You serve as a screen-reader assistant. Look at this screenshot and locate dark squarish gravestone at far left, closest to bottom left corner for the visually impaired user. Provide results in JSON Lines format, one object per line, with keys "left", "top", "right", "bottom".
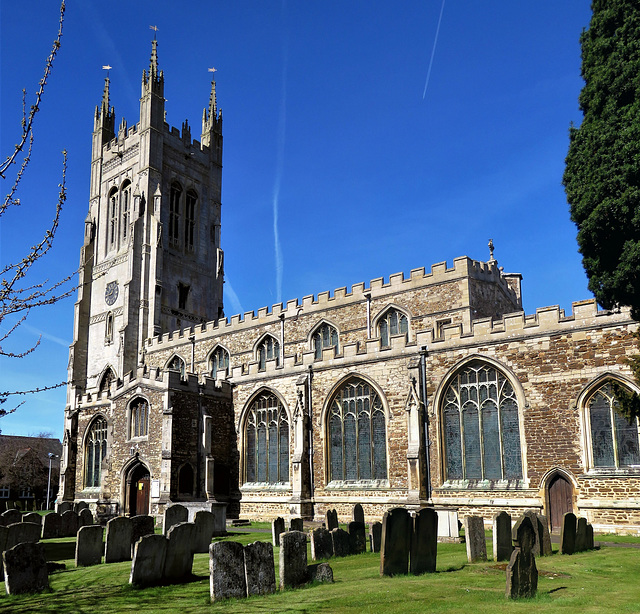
{"left": 2, "top": 543, "right": 49, "bottom": 595}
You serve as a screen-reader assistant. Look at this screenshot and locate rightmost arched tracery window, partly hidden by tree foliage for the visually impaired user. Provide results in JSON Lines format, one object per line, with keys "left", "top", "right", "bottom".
{"left": 587, "top": 383, "right": 640, "bottom": 468}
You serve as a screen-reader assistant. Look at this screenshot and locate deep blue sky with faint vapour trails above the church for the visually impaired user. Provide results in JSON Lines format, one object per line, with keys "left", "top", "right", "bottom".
{"left": 0, "top": 0, "right": 591, "bottom": 436}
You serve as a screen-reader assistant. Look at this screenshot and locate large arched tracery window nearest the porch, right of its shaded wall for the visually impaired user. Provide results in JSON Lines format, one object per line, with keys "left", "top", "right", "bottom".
{"left": 244, "top": 392, "right": 289, "bottom": 484}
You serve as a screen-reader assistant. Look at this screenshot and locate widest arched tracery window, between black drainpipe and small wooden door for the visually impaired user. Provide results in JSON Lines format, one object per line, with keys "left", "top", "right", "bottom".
{"left": 442, "top": 360, "right": 522, "bottom": 480}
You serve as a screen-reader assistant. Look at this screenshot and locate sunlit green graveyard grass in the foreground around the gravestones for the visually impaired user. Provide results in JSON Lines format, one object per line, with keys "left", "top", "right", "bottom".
{"left": 0, "top": 533, "right": 640, "bottom": 614}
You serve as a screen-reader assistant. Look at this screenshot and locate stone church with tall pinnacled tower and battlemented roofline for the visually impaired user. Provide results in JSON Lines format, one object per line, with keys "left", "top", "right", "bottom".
{"left": 58, "top": 41, "right": 640, "bottom": 532}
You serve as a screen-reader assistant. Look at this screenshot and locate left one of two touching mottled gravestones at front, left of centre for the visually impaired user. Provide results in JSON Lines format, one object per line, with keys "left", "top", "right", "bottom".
{"left": 209, "top": 542, "right": 248, "bottom": 601}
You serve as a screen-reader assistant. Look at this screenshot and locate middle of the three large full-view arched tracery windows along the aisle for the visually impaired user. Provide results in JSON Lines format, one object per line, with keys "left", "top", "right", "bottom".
{"left": 327, "top": 377, "right": 387, "bottom": 481}
